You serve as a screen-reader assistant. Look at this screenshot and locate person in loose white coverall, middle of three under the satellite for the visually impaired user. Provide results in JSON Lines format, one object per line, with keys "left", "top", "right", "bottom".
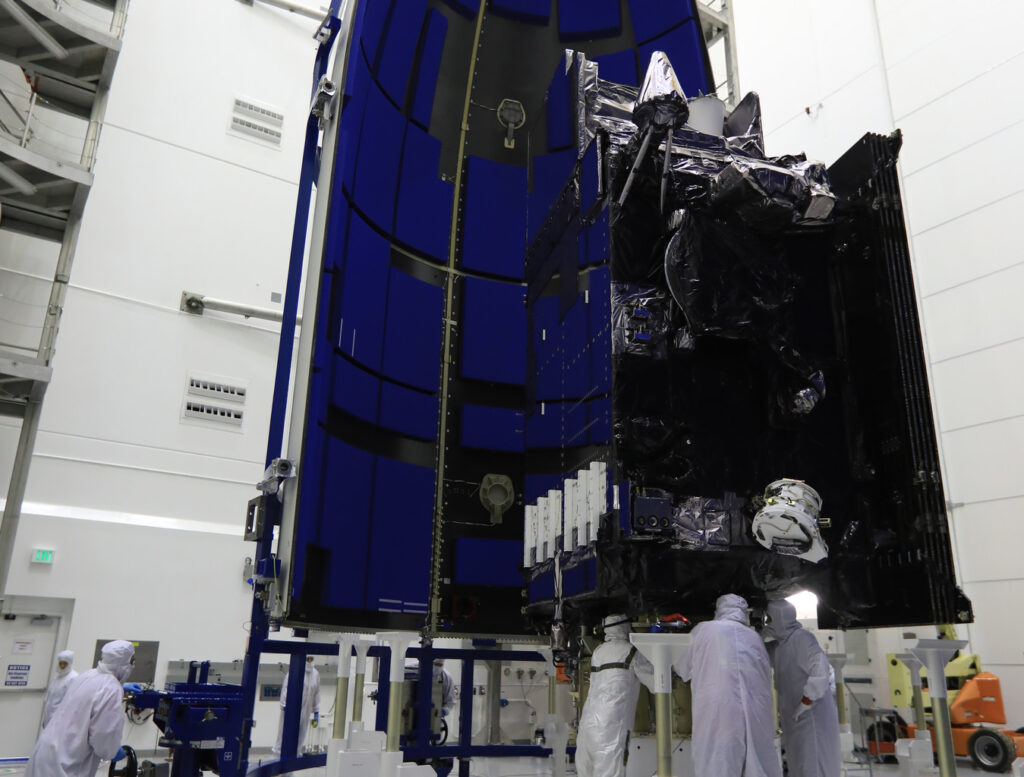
{"left": 673, "top": 594, "right": 782, "bottom": 777}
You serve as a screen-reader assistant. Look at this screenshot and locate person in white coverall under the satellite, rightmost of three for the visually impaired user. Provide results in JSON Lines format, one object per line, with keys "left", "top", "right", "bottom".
{"left": 764, "top": 601, "right": 842, "bottom": 777}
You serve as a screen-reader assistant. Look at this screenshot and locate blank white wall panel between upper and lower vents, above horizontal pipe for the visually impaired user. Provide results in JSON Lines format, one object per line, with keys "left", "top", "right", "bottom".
{"left": 74, "top": 127, "right": 298, "bottom": 309}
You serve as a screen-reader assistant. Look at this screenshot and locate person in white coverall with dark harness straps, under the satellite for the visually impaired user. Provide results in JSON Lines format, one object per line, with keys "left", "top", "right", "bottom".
{"left": 575, "top": 615, "right": 654, "bottom": 777}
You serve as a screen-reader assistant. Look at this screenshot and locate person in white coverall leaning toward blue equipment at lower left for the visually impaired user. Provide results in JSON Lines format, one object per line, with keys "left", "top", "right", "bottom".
{"left": 25, "top": 640, "right": 135, "bottom": 777}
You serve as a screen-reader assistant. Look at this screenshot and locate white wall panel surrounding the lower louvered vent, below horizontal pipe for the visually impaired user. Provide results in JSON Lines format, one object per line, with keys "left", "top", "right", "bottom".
{"left": 41, "top": 289, "right": 278, "bottom": 463}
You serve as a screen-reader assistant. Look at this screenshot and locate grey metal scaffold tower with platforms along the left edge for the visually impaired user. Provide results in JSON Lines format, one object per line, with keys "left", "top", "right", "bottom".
{"left": 0, "top": 0, "right": 128, "bottom": 595}
